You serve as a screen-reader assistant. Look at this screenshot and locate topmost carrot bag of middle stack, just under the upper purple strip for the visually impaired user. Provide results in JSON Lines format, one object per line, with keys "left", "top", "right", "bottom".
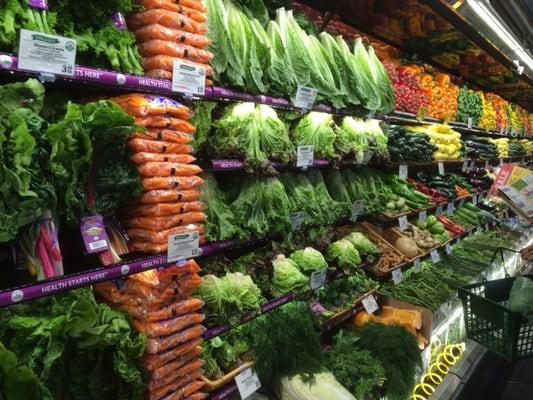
{"left": 112, "top": 93, "right": 193, "bottom": 119}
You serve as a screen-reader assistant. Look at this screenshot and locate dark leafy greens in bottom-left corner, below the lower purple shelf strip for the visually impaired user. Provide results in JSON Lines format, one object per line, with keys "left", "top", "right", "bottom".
{"left": 0, "top": 287, "right": 145, "bottom": 400}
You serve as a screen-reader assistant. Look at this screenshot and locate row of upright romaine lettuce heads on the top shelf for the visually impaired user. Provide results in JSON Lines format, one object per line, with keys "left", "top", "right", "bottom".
{"left": 205, "top": 0, "right": 394, "bottom": 114}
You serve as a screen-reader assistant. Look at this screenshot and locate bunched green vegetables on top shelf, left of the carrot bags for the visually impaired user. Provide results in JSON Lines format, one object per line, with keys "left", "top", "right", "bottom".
{"left": 0, "top": 0, "right": 143, "bottom": 74}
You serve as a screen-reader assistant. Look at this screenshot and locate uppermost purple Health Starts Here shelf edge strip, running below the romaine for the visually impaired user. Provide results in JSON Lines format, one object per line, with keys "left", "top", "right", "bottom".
{"left": 0, "top": 53, "right": 528, "bottom": 138}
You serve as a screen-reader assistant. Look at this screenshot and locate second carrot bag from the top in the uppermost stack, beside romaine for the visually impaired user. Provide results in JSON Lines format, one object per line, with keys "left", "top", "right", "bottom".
{"left": 128, "top": 9, "right": 207, "bottom": 35}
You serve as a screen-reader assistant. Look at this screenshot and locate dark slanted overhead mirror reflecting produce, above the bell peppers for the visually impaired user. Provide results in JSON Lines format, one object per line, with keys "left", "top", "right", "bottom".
{"left": 300, "top": 0, "right": 533, "bottom": 112}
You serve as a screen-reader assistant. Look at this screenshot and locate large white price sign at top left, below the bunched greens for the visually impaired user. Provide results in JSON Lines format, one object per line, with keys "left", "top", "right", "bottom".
{"left": 18, "top": 29, "right": 76, "bottom": 76}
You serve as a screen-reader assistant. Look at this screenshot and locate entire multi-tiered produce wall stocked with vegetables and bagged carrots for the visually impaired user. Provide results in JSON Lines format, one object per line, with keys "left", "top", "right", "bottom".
{"left": 0, "top": 0, "right": 533, "bottom": 400}
